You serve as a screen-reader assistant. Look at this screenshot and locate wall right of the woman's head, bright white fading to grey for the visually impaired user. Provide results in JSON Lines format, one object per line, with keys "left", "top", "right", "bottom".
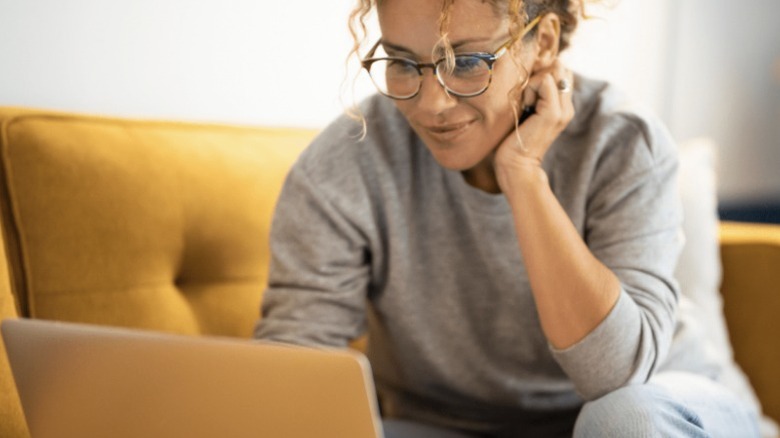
{"left": 569, "top": 0, "right": 780, "bottom": 204}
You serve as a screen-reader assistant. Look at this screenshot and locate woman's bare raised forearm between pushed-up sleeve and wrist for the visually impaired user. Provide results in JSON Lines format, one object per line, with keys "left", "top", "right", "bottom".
{"left": 502, "top": 164, "right": 620, "bottom": 349}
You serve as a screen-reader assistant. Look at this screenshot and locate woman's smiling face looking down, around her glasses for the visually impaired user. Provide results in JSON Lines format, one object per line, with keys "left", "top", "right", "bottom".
{"left": 378, "top": 0, "right": 529, "bottom": 175}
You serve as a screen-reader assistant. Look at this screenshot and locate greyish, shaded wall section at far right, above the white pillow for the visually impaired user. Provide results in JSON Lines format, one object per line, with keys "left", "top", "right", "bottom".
{"left": 669, "top": 0, "right": 780, "bottom": 203}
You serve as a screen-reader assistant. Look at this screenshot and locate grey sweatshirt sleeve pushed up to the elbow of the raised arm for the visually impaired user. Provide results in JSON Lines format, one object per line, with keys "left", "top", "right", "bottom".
{"left": 551, "top": 116, "right": 682, "bottom": 400}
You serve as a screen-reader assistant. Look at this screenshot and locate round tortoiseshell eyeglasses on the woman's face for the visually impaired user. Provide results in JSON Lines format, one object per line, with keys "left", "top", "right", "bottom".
{"left": 361, "top": 16, "right": 541, "bottom": 100}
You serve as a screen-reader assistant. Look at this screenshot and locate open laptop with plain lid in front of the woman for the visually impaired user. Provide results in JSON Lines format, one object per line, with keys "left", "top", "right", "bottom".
{"left": 0, "top": 319, "right": 382, "bottom": 438}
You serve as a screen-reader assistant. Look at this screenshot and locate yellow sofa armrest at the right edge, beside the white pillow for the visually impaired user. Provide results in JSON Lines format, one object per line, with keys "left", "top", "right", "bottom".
{"left": 720, "top": 222, "right": 780, "bottom": 421}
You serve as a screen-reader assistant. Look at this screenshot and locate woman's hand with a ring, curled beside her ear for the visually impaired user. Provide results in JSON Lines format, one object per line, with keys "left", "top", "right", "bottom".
{"left": 494, "top": 60, "right": 574, "bottom": 192}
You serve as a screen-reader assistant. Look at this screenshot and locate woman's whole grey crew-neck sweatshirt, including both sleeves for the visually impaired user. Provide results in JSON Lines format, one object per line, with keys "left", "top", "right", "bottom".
{"left": 256, "top": 77, "right": 711, "bottom": 432}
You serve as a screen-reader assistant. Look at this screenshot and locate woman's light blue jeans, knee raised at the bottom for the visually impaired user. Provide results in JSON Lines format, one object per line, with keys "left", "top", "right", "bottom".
{"left": 384, "top": 372, "right": 759, "bottom": 438}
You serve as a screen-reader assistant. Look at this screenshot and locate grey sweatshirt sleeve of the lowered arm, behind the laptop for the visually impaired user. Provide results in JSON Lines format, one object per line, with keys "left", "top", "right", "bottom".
{"left": 255, "top": 157, "right": 369, "bottom": 347}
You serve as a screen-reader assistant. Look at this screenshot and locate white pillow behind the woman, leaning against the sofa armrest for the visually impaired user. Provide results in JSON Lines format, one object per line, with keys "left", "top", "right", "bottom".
{"left": 675, "top": 138, "right": 777, "bottom": 437}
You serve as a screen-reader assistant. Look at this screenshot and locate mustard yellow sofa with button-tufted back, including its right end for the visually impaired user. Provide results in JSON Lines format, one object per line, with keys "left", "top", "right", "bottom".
{"left": 0, "top": 108, "right": 780, "bottom": 438}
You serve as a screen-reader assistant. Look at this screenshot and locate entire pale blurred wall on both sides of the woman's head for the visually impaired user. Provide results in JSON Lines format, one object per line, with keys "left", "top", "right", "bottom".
{"left": 0, "top": 0, "right": 780, "bottom": 199}
